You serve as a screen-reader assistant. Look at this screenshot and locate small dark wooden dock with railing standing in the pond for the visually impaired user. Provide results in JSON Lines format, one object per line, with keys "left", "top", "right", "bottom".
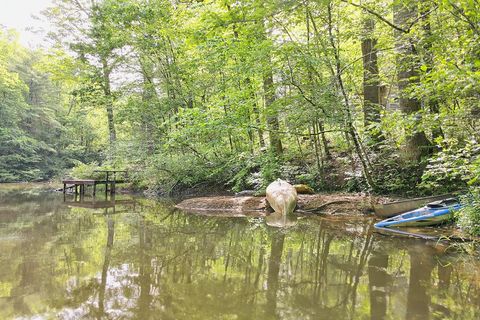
{"left": 62, "top": 170, "right": 127, "bottom": 196}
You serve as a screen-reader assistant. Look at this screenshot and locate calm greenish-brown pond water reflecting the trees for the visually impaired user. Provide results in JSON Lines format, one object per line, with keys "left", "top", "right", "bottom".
{"left": 0, "top": 185, "right": 480, "bottom": 319}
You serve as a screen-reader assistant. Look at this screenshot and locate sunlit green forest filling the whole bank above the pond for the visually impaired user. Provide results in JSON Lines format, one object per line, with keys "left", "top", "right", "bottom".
{"left": 0, "top": 0, "right": 480, "bottom": 195}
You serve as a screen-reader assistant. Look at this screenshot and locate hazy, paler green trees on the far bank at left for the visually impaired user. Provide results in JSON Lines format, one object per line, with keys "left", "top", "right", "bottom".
{"left": 0, "top": 30, "right": 99, "bottom": 182}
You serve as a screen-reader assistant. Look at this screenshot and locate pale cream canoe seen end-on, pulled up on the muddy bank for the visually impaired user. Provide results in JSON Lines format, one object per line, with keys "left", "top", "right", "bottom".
{"left": 266, "top": 179, "right": 298, "bottom": 214}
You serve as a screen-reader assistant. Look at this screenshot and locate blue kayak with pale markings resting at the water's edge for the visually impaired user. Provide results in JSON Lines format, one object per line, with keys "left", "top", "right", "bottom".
{"left": 375, "top": 198, "right": 462, "bottom": 228}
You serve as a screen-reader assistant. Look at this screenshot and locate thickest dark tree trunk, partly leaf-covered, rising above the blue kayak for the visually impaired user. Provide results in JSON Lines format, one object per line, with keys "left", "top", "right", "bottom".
{"left": 393, "top": 2, "right": 431, "bottom": 162}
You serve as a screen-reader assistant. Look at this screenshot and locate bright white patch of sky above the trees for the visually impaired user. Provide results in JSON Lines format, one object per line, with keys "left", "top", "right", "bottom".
{"left": 0, "top": 0, "right": 52, "bottom": 47}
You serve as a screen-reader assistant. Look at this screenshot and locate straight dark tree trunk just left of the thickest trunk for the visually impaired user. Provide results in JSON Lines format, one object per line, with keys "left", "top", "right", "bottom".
{"left": 362, "top": 16, "right": 381, "bottom": 142}
